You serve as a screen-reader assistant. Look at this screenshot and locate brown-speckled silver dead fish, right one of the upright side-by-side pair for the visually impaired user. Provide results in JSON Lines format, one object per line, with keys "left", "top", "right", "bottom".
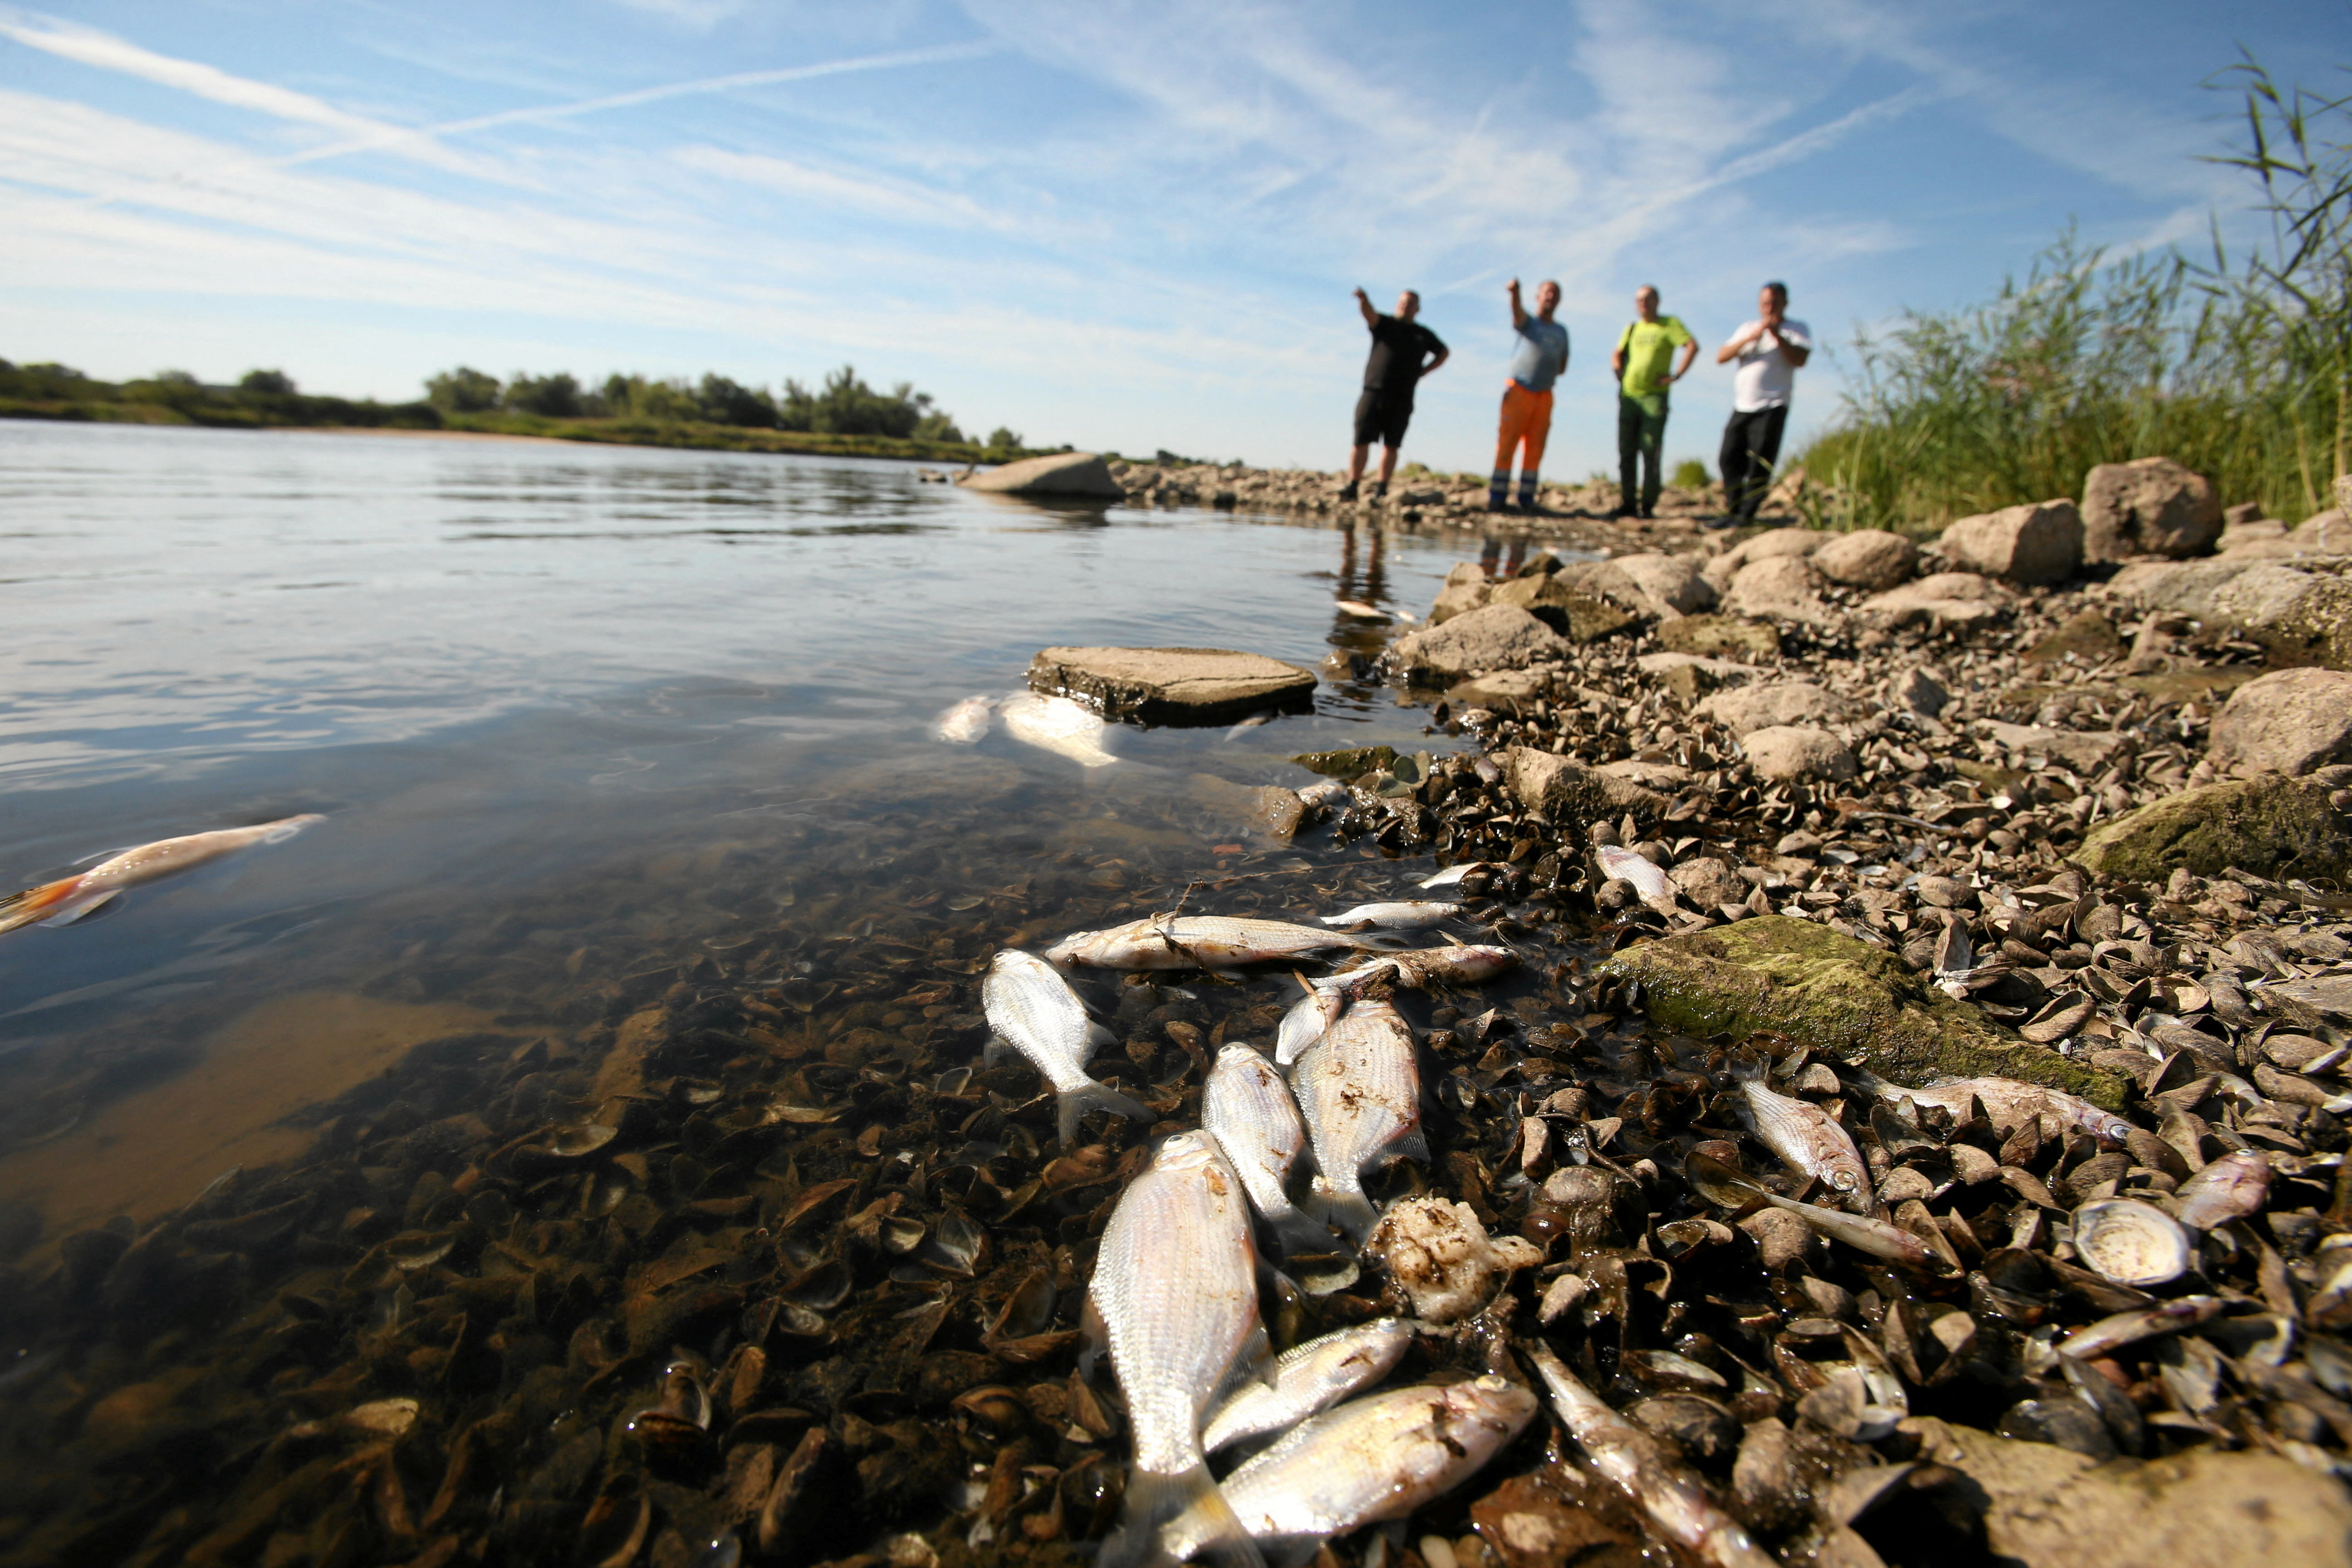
{"left": 1291, "top": 1001, "right": 1430, "bottom": 1244}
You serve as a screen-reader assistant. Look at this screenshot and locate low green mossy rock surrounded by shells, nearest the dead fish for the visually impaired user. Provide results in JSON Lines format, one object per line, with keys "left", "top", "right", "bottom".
{"left": 1597, "top": 915, "right": 2124, "bottom": 1110}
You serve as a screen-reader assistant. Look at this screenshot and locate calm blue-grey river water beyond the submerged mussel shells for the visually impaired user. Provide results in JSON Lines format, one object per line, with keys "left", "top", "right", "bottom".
{"left": 0, "top": 423, "right": 1486, "bottom": 1251}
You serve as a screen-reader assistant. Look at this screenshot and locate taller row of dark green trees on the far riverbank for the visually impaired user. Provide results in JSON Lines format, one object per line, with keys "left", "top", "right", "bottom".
{"left": 426, "top": 364, "right": 1021, "bottom": 451}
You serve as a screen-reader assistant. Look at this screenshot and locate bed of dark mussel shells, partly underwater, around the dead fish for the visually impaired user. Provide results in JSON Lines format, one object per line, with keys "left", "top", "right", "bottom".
{"left": 0, "top": 557, "right": 2352, "bottom": 1568}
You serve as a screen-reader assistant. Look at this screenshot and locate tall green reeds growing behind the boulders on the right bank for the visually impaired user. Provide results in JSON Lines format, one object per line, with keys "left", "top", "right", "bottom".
{"left": 1797, "top": 59, "right": 2352, "bottom": 531}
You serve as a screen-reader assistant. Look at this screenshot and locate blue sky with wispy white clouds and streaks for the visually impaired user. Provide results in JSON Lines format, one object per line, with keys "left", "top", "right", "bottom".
{"left": 0, "top": 0, "right": 2352, "bottom": 477}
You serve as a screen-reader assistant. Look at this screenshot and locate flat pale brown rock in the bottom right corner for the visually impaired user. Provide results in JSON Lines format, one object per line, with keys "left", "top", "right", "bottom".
{"left": 1891, "top": 1420, "right": 2352, "bottom": 1568}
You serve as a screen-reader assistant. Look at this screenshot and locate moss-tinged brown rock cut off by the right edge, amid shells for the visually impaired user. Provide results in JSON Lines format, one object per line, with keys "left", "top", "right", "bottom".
{"left": 2074, "top": 774, "right": 2352, "bottom": 882}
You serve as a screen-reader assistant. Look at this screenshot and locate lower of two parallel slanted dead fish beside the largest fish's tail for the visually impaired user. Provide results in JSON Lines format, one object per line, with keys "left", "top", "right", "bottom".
{"left": 1160, "top": 1373, "right": 1536, "bottom": 1568}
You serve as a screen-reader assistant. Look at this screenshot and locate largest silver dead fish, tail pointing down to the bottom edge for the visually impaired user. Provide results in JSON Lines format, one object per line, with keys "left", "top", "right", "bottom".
{"left": 1087, "top": 1133, "right": 1270, "bottom": 1568}
